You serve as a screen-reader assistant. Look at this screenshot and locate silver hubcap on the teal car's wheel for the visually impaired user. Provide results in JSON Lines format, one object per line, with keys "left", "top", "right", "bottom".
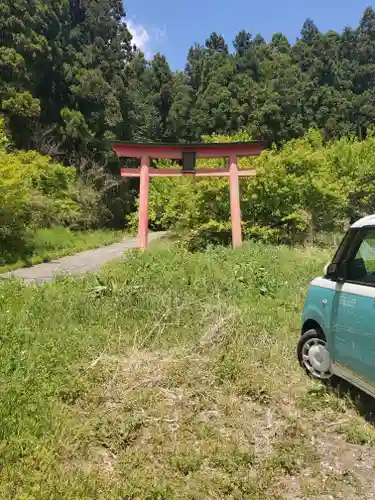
{"left": 302, "top": 338, "right": 331, "bottom": 379}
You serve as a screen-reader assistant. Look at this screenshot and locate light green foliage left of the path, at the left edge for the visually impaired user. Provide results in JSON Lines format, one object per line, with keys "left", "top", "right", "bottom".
{"left": 0, "top": 122, "right": 104, "bottom": 265}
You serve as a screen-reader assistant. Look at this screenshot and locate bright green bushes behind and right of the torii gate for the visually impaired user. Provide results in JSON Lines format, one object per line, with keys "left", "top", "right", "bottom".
{"left": 136, "top": 130, "right": 375, "bottom": 250}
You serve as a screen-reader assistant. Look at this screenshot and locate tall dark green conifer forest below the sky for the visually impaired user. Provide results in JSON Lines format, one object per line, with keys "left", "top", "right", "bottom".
{"left": 0, "top": 0, "right": 375, "bottom": 247}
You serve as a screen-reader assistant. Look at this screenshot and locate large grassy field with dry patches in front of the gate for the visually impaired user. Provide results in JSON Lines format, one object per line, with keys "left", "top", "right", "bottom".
{"left": 0, "top": 242, "right": 375, "bottom": 500}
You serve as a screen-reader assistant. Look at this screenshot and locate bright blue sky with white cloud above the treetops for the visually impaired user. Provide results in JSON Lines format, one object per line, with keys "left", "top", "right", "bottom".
{"left": 124, "top": 0, "right": 370, "bottom": 69}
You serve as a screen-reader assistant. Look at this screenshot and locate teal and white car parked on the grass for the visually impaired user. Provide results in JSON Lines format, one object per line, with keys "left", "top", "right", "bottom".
{"left": 297, "top": 215, "right": 375, "bottom": 397}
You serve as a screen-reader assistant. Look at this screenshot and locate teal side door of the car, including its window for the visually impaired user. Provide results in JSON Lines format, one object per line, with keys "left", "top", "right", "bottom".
{"left": 332, "top": 229, "right": 375, "bottom": 384}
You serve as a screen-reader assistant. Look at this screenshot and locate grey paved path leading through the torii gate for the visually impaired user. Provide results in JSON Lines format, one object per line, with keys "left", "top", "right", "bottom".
{"left": 0, "top": 232, "right": 165, "bottom": 283}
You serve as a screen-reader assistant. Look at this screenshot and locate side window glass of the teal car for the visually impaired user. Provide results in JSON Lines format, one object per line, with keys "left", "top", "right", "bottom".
{"left": 347, "top": 230, "right": 375, "bottom": 286}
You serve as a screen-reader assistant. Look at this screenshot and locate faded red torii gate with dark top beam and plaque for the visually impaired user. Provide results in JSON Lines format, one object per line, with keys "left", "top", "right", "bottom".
{"left": 112, "top": 141, "right": 266, "bottom": 249}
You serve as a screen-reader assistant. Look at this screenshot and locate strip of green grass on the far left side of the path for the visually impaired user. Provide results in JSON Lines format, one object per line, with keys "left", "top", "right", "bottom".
{"left": 0, "top": 227, "right": 125, "bottom": 273}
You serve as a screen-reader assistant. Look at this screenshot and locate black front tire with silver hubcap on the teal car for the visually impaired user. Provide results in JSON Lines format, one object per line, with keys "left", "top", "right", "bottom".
{"left": 297, "top": 330, "right": 332, "bottom": 381}
